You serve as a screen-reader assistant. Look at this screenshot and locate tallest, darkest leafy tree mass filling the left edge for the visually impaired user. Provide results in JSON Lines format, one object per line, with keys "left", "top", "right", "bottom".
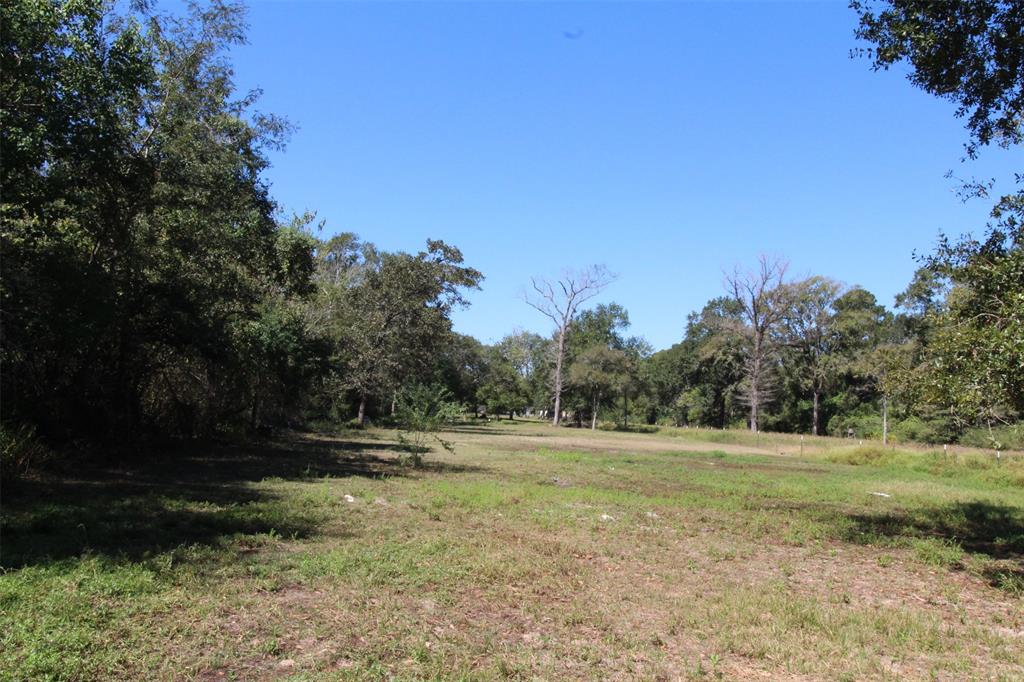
{"left": 0, "top": 0, "right": 312, "bottom": 442}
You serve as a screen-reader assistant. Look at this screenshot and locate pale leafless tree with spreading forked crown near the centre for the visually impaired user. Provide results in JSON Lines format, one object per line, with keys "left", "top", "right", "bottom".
{"left": 523, "top": 265, "right": 615, "bottom": 426}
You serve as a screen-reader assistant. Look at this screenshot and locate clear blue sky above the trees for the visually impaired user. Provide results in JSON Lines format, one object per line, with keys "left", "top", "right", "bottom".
{"left": 224, "top": 2, "right": 1011, "bottom": 348}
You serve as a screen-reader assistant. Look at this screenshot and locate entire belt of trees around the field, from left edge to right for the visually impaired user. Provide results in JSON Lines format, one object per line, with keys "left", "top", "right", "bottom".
{"left": 0, "top": 0, "right": 1024, "bottom": 466}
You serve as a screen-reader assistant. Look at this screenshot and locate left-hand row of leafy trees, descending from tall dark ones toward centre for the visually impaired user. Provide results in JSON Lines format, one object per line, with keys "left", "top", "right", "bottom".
{"left": 0, "top": 0, "right": 481, "bottom": 456}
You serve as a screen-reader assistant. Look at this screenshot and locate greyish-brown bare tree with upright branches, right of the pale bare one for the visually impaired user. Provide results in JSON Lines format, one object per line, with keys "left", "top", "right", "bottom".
{"left": 725, "top": 256, "right": 790, "bottom": 431}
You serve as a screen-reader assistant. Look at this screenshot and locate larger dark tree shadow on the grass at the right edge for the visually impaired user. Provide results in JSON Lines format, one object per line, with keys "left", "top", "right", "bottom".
{"left": 848, "top": 502, "right": 1024, "bottom": 567}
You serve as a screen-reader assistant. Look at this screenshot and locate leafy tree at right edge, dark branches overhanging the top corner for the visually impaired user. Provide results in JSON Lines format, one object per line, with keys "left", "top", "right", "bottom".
{"left": 852, "top": 0, "right": 1024, "bottom": 422}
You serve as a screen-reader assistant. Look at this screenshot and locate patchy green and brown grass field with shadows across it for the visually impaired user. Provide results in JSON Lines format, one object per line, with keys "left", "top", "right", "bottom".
{"left": 0, "top": 423, "right": 1024, "bottom": 680}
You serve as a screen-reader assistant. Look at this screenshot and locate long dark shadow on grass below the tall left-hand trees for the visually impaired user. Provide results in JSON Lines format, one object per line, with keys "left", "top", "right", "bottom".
{"left": 0, "top": 430, "right": 483, "bottom": 568}
